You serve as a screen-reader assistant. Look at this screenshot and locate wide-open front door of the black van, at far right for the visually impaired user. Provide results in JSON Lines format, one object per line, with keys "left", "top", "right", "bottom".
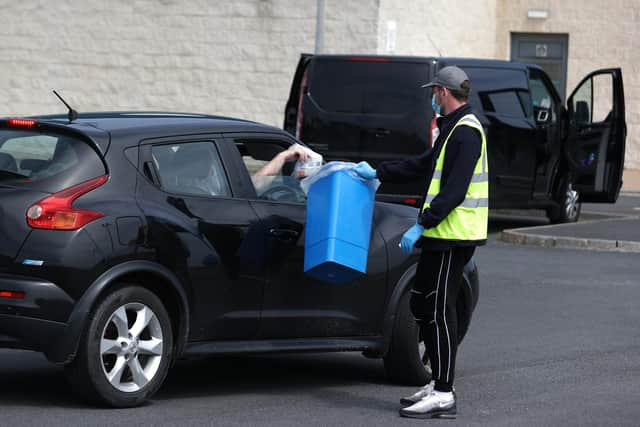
{"left": 566, "top": 68, "right": 627, "bottom": 203}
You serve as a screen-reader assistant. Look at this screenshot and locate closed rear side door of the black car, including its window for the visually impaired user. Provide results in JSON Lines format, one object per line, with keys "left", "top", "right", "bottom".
{"left": 138, "top": 135, "right": 264, "bottom": 341}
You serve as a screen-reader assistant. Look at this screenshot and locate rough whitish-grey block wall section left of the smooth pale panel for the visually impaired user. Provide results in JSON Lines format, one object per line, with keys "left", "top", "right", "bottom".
{"left": 0, "top": 0, "right": 378, "bottom": 126}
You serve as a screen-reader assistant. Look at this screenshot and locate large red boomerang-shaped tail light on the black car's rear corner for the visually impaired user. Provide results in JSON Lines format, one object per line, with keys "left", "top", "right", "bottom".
{"left": 27, "top": 175, "right": 108, "bottom": 230}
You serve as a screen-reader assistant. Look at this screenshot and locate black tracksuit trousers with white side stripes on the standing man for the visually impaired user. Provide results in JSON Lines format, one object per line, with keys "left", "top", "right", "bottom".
{"left": 410, "top": 246, "right": 475, "bottom": 391}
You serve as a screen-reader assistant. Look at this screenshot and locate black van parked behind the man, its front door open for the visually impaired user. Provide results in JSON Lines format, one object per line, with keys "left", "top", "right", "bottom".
{"left": 284, "top": 54, "right": 626, "bottom": 222}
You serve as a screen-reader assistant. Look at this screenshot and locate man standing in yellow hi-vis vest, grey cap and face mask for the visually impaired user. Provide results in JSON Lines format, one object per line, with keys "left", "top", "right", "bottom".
{"left": 354, "top": 66, "right": 489, "bottom": 418}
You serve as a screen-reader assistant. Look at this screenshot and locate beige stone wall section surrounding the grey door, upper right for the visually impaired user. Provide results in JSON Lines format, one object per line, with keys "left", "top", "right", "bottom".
{"left": 496, "top": 0, "right": 640, "bottom": 169}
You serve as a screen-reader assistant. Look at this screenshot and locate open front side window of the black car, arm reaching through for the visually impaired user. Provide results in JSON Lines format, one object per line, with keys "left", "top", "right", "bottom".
{"left": 236, "top": 139, "right": 307, "bottom": 203}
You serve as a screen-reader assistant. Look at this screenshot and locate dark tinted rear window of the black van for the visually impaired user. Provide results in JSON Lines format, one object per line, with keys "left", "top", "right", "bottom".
{"left": 309, "top": 60, "right": 430, "bottom": 115}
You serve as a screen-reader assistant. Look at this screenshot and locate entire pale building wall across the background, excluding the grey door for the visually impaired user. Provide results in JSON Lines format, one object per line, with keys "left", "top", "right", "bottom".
{"left": 0, "top": 0, "right": 640, "bottom": 169}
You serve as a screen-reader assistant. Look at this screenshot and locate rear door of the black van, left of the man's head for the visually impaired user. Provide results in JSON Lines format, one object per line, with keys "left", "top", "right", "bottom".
{"left": 285, "top": 55, "right": 433, "bottom": 206}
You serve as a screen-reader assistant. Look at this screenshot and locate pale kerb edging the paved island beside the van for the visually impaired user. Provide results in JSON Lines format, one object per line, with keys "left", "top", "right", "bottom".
{"left": 498, "top": 216, "right": 640, "bottom": 253}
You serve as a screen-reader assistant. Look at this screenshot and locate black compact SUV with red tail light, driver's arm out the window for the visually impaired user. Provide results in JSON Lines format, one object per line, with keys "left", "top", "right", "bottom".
{"left": 0, "top": 113, "right": 478, "bottom": 407}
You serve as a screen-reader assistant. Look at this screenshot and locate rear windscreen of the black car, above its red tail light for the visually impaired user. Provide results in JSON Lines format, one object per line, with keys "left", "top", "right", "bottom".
{"left": 0, "top": 129, "right": 105, "bottom": 193}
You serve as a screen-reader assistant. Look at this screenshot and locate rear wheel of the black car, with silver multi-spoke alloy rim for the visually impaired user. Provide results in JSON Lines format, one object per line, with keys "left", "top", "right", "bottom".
{"left": 66, "top": 286, "right": 173, "bottom": 407}
